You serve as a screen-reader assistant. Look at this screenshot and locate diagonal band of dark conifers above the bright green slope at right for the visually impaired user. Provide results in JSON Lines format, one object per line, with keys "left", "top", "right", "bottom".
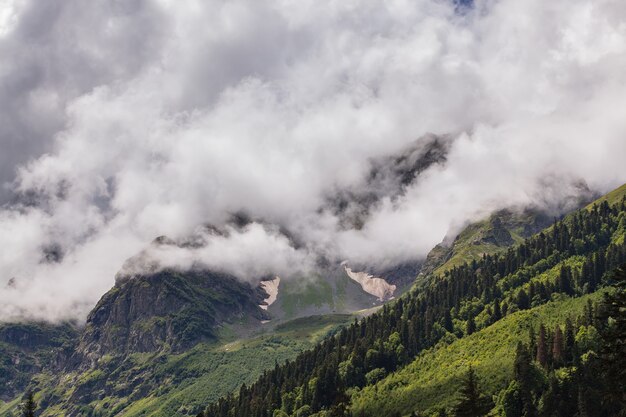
{"left": 201, "top": 199, "right": 626, "bottom": 417}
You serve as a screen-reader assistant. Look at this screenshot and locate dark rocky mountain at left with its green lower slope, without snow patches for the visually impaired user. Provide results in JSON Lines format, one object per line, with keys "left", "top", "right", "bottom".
{"left": 0, "top": 270, "right": 354, "bottom": 416}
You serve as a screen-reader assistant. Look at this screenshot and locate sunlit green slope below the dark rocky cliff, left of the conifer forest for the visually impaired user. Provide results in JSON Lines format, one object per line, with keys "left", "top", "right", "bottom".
{"left": 15, "top": 314, "right": 354, "bottom": 417}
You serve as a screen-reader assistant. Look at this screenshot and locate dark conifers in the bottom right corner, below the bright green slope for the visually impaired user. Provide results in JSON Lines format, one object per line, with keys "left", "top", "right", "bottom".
{"left": 450, "top": 267, "right": 626, "bottom": 417}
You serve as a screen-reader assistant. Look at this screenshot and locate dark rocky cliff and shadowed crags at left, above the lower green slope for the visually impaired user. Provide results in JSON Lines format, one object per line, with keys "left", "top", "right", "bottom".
{"left": 0, "top": 270, "right": 269, "bottom": 416}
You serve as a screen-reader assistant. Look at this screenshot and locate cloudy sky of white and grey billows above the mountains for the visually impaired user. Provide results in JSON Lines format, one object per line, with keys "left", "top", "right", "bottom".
{"left": 0, "top": 0, "right": 626, "bottom": 321}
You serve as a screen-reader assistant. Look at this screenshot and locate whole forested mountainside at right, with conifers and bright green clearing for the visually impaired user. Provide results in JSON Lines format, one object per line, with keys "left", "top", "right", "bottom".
{"left": 203, "top": 182, "right": 626, "bottom": 417}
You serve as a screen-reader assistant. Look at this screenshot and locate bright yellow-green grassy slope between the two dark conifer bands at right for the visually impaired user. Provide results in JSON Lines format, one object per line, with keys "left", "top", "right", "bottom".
{"left": 352, "top": 291, "right": 600, "bottom": 415}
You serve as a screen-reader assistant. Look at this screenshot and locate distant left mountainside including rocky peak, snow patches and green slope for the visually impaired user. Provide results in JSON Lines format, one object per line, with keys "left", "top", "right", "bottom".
{"left": 0, "top": 220, "right": 414, "bottom": 416}
